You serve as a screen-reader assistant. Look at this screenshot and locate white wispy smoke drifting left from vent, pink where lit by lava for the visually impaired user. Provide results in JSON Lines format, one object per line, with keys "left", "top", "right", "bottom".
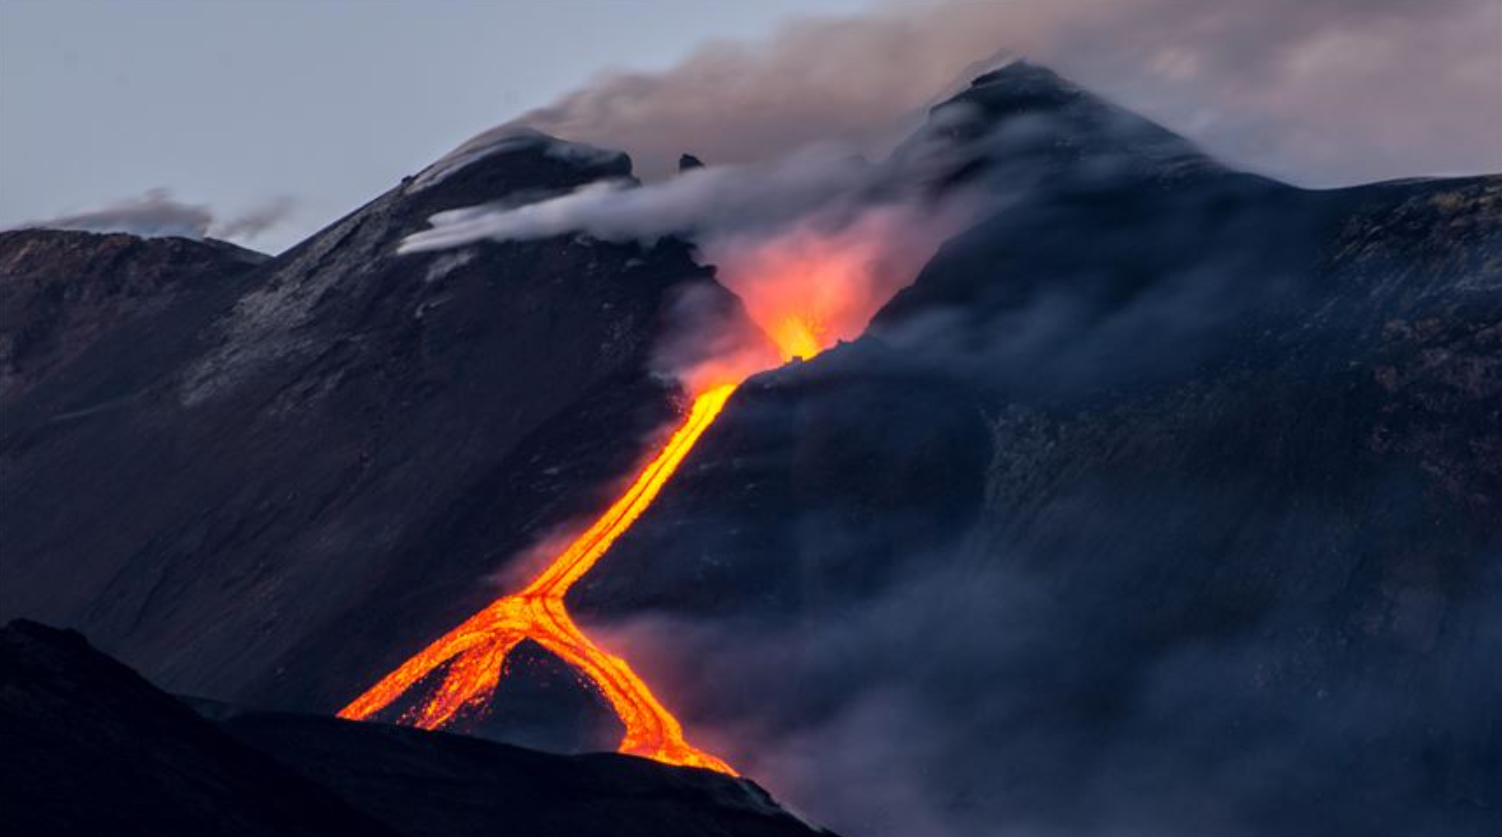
{"left": 401, "top": 134, "right": 966, "bottom": 391}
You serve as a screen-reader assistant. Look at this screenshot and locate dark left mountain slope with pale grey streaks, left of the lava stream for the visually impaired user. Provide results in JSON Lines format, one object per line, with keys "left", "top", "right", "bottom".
{"left": 0, "top": 137, "right": 751, "bottom": 730}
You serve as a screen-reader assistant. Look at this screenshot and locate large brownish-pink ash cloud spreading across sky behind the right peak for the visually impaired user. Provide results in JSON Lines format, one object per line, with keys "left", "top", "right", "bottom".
{"left": 517, "top": 0, "right": 1502, "bottom": 185}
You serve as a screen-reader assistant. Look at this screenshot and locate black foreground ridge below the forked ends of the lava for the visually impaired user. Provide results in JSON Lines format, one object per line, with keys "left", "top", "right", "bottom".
{"left": 0, "top": 621, "right": 816, "bottom": 837}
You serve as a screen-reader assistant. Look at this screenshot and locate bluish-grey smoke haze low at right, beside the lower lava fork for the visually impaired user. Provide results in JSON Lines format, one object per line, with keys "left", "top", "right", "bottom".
{"left": 610, "top": 525, "right": 1502, "bottom": 837}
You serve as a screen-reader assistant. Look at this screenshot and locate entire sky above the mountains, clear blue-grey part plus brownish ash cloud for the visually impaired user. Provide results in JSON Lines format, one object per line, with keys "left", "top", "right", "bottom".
{"left": 0, "top": 0, "right": 1502, "bottom": 252}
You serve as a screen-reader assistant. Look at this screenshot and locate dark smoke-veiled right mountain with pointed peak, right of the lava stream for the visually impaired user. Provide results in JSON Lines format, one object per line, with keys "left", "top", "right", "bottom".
{"left": 575, "top": 65, "right": 1502, "bottom": 835}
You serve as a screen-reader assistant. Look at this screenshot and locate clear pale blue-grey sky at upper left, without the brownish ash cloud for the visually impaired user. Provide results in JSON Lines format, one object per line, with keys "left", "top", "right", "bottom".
{"left": 0, "top": 0, "right": 873, "bottom": 251}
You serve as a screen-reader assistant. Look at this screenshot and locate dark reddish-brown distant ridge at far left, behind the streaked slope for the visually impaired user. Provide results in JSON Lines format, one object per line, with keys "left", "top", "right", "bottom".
{"left": 0, "top": 228, "right": 267, "bottom": 407}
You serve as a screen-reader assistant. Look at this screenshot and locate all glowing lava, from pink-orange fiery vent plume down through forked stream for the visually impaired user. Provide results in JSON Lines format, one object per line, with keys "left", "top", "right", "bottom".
{"left": 339, "top": 215, "right": 931, "bottom": 775}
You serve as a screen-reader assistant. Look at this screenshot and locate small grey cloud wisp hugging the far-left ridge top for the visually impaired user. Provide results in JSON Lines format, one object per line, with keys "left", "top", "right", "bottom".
{"left": 23, "top": 189, "right": 294, "bottom": 240}
